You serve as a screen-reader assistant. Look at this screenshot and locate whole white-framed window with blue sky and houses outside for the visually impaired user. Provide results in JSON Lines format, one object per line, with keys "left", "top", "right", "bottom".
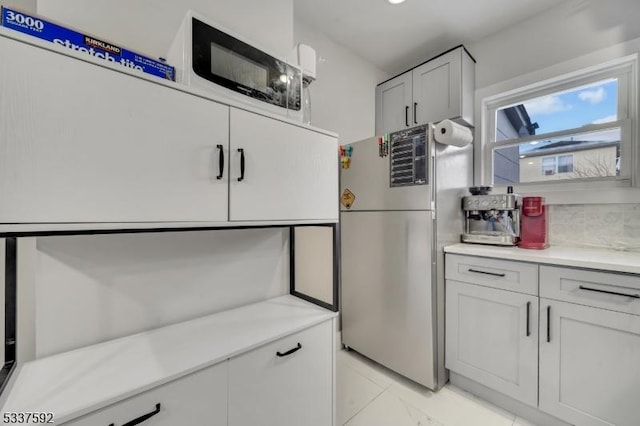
{"left": 481, "top": 56, "right": 636, "bottom": 185}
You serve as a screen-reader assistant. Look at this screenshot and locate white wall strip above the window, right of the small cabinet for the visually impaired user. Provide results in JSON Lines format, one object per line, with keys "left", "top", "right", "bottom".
{"left": 467, "top": 0, "right": 640, "bottom": 89}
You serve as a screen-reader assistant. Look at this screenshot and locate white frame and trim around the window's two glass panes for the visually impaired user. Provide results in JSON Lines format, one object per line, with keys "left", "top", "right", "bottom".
{"left": 475, "top": 53, "right": 640, "bottom": 203}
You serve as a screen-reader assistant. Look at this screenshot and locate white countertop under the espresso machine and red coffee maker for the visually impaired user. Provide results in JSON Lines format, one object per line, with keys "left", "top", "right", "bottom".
{"left": 444, "top": 244, "right": 640, "bottom": 274}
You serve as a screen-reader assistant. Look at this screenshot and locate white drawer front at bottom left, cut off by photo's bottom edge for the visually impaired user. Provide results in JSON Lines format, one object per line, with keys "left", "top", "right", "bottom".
{"left": 64, "top": 361, "right": 228, "bottom": 426}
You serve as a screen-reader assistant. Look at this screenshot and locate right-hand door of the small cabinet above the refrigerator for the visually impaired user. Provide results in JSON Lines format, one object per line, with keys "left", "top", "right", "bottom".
{"left": 413, "top": 48, "right": 462, "bottom": 124}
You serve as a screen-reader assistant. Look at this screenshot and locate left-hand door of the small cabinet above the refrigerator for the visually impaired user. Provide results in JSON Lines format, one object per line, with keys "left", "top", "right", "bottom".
{"left": 376, "top": 71, "right": 415, "bottom": 135}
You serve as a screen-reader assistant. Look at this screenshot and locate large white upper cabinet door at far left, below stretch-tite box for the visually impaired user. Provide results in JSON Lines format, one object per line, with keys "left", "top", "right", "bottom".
{"left": 0, "top": 38, "right": 228, "bottom": 223}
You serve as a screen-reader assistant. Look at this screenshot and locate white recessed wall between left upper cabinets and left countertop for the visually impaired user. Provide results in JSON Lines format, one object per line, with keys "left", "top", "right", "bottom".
{"left": 30, "top": 229, "right": 289, "bottom": 358}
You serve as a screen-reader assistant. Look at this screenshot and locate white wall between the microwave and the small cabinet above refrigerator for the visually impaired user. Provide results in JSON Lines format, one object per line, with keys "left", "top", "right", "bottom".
{"left": 294, "top": 17, "right": 390, "bottom": 144}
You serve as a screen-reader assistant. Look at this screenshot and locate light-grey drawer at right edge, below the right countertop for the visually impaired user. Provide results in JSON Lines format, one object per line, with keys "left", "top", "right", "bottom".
{"left": 540, "top": 266, "right": 640, "bottom": 315}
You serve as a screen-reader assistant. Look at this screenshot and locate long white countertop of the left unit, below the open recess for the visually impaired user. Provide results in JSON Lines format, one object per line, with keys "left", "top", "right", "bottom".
{"left": 2, "top": 295, "right": 337, "bottom": 424}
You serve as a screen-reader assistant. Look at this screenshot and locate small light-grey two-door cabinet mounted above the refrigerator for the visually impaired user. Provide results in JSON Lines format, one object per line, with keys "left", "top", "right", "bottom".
{"left": 376, "top": 46, "right": 475, "bottom": 134}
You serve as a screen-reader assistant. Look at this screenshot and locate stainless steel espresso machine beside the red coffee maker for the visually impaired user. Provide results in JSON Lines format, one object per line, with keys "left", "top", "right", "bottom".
{"left": 462, "top": 187, "right": 520, "bottom": 246}
